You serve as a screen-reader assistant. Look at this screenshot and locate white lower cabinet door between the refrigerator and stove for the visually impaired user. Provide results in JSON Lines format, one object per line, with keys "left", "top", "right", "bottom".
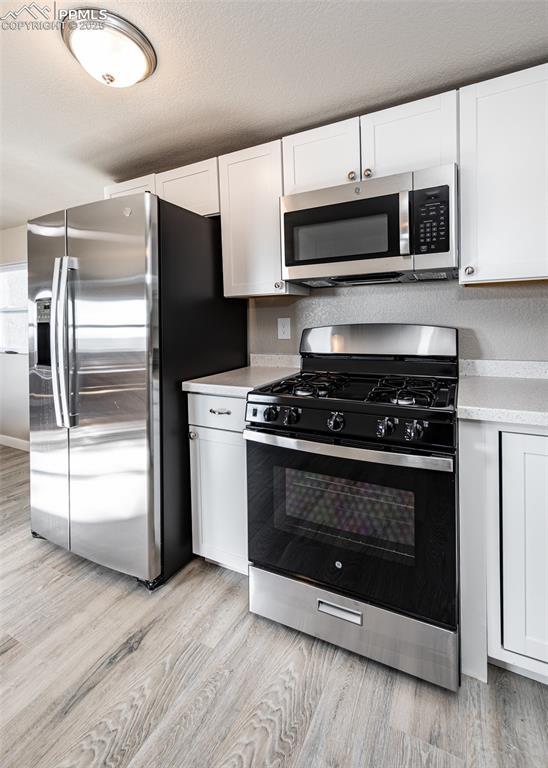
{"left": 190, "top": 426, "right": 248, "bottom": 574}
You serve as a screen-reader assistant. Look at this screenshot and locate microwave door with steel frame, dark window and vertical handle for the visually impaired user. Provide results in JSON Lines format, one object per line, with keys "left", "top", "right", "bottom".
{"left": 281, "top": 173, "right": 412, "bottom": 281}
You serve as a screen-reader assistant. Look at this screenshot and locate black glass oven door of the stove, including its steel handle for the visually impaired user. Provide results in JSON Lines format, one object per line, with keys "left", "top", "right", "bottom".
{"left": 244, "top": 430, "right": 457, "bottom": 628}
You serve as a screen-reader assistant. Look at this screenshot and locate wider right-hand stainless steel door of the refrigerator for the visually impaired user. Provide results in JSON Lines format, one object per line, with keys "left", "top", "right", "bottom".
{"left": 67, "top": 194, "right": 161, "bottom": 581}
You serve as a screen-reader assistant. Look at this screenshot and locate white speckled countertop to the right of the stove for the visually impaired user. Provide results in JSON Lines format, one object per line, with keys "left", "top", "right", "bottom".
{"left": 457, "top": 376, "right": 548, "bottom": 427}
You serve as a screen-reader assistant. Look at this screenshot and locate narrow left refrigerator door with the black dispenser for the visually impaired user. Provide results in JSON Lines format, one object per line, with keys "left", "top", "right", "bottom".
{"left": 27, "top": 211, "right": 70, "bottom": 549}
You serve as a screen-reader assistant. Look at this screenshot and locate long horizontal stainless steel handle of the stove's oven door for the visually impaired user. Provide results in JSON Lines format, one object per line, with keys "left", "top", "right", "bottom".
{"left": 244, "top": 429, "right": 453, "bottom": 472}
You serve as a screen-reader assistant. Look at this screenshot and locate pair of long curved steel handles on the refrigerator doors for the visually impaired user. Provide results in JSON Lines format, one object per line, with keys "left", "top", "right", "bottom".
{"left": 51, "top": 256, "right": 78, "bottom": 429}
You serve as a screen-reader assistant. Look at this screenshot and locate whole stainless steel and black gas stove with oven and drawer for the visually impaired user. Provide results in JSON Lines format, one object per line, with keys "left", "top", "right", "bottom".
{"left": 244, "top": 324, "right": 459, "bottom": 690}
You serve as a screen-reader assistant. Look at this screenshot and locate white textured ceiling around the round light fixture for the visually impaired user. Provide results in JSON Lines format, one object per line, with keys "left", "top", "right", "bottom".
{"left": 0, "top": 0, "right": 548, "bottom": 228}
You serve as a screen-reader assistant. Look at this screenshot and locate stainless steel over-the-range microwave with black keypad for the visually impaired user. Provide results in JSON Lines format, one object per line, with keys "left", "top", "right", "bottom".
{"left": 281, "top": 164, "right": 458, "bottom": 287}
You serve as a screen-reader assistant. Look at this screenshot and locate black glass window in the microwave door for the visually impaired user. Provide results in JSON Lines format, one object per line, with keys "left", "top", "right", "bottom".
{"left": 284, "top": 195, "right": 400, "bottom": 267}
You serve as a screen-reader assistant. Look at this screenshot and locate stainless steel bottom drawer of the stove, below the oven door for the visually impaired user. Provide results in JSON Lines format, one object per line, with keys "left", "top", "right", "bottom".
{"left": 249, "top": 566, "right": 459, "bottom": 691}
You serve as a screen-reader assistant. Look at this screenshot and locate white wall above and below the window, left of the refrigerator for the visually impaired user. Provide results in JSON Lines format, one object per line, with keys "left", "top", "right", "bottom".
{"left": 0, "top": 225, "right": 29, "bottom": 447}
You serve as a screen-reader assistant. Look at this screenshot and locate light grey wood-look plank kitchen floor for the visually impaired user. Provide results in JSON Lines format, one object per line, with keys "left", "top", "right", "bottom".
{"left": 0, "top": 447, "right": 548, "bottom": 768}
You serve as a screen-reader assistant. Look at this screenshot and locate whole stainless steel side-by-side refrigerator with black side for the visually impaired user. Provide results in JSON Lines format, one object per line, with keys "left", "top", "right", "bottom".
{"left": 28, "top": 193, "right": 247, "bottom": 588}
